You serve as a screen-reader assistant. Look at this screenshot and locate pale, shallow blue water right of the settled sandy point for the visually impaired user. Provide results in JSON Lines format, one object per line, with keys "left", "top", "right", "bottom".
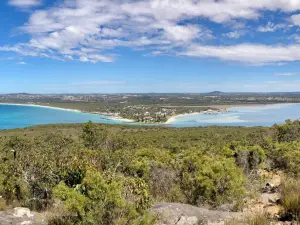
{"left": 171, "top": 104, "right": 300, "bottom": 127}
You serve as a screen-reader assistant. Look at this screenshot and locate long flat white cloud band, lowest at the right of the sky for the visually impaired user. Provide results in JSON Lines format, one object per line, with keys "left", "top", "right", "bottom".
{"left": 179, "top": 44, "right": 300, "bottom": 65}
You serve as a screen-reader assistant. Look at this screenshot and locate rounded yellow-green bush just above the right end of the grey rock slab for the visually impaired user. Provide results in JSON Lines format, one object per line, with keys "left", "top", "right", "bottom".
{"left": 181, "top": 152, "right": 245, "bottom": 205}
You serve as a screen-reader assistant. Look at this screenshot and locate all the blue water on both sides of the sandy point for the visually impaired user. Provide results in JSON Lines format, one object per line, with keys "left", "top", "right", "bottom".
{"left": 0, "top": 104, "right": 300, "bottom": 129}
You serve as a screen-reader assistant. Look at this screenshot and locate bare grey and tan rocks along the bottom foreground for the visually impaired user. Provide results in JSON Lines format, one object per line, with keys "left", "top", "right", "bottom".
{"left": 0, "top": 171, "right": 293, "bottom": 225}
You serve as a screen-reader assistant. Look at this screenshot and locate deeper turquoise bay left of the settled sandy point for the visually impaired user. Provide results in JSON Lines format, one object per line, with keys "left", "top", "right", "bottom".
{"left": 0, "top": 105, "right": 129, "bottom": 129}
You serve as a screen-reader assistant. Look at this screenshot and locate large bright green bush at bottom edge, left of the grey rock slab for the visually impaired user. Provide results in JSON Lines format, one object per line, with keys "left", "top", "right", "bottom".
{"left": 54, "top": 168, "right": 151, "bottom": 225}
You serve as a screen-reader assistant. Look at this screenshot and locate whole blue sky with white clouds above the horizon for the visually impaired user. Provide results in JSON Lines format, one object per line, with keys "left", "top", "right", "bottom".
{"left": 0, "top": 0, "right": 300, "bottom": 93}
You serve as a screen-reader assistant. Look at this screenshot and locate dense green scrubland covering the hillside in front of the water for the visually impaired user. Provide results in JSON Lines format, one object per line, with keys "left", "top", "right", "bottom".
{"left": 0, "top": 121, "right": 300, "bottom": 225}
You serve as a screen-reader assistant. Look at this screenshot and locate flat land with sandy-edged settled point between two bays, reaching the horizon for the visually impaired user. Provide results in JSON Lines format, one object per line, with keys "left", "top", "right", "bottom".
{"left": 0, "top": 92, "right": 300, "bottom": 124}
